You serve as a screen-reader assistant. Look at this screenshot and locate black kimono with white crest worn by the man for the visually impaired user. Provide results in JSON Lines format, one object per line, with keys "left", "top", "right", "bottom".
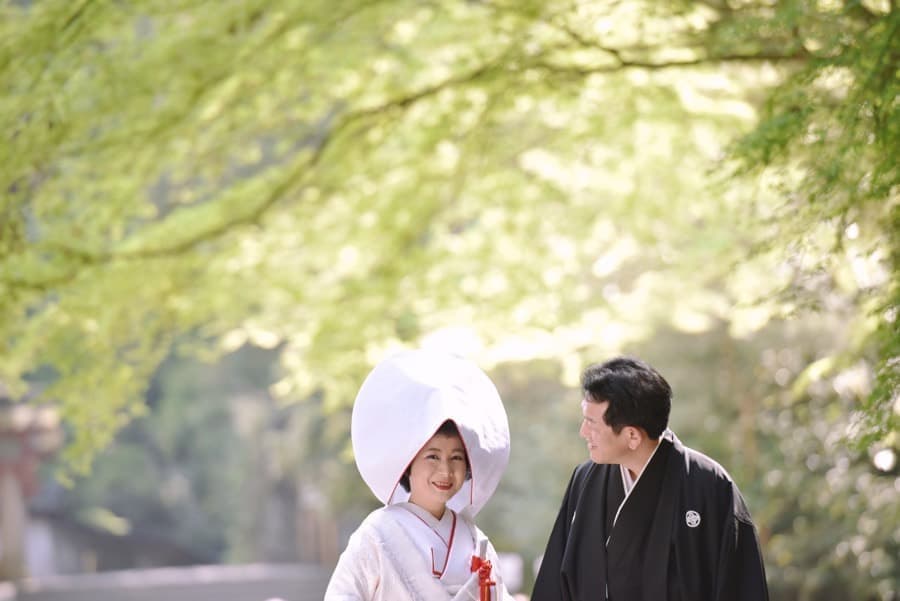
{"left": 531, "top": 431, "right": 769, "bottom": 601}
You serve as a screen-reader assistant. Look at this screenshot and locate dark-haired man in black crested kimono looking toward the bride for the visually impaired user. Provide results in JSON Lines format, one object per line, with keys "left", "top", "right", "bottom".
{"left": 531, "top": 357, "right": 769, "bottom": 601}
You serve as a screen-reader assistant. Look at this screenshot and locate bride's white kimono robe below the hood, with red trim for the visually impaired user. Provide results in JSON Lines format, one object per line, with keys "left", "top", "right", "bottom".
{"left": 325, "top": 503, "right": 512, "bottom": 601}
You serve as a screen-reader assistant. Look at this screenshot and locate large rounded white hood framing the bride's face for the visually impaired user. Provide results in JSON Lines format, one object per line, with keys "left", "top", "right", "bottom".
{"left": 350, "top": 350, "right": 509, "bottom": 515}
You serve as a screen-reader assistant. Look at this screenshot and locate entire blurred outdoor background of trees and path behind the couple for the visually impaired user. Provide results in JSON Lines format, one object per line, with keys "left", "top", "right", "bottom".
{"left": 0, "top": 0, "right": 900, "bottom": 601}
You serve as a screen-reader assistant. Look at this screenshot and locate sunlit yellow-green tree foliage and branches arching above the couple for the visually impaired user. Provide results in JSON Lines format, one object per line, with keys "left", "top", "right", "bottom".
{"left": 0, "top": 0, "right": 900, "bottom": 594}
